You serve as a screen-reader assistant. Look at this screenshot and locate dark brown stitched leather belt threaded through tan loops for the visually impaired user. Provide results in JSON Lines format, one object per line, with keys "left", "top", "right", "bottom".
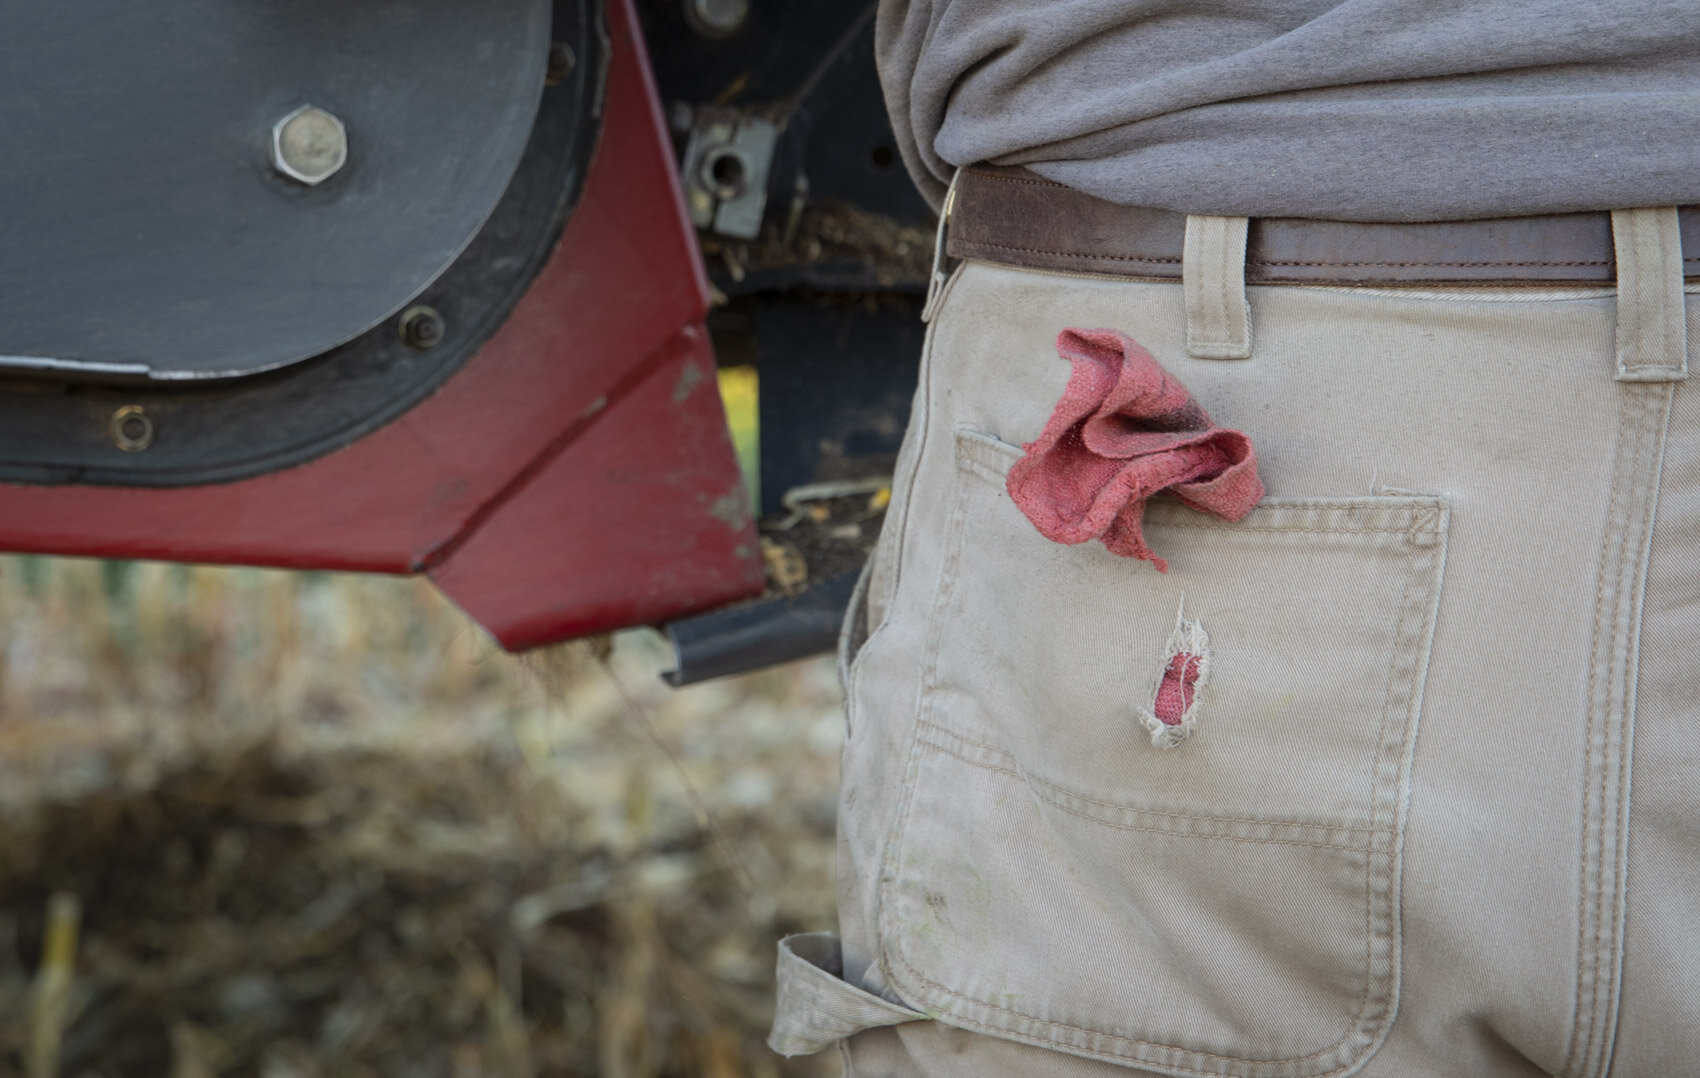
{"left": 945, "top": 165, "right": 1700, "bottom": 284}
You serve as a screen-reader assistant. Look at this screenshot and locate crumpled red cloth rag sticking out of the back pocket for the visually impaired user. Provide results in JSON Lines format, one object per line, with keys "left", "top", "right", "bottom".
{"left": 1008, "top": 330, "right": 1263, "bottom": 571}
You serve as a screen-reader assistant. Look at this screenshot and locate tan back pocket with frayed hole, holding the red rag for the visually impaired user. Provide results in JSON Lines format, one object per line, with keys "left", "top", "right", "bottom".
{"left": 879, "top": 430, "right": 1448, "bottom": 1078}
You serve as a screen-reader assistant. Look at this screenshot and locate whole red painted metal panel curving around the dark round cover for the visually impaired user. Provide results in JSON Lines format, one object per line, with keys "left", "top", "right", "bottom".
{"left": 0, "top": 0, "right": 762, "bottom": 648}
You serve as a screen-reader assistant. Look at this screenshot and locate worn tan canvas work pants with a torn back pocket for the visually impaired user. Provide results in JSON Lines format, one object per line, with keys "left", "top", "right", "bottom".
{"left": 774, "top": 205, "right": 1700, "bottom": 1078}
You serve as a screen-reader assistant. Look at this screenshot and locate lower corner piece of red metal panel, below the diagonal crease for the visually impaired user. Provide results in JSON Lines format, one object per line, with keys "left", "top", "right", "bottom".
{"left": 430, "top": 330, "right": 763, "bottom": 650}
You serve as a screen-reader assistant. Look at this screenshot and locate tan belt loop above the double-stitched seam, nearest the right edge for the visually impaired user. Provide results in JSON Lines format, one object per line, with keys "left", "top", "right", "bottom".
{"left": 1612, "top": 206, "right": 1688, "bottom": 383}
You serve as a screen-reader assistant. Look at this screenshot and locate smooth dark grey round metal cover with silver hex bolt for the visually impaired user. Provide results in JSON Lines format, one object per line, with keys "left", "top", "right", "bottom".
{"left": 0, "top": 0, "right": 551, "bottom": 383}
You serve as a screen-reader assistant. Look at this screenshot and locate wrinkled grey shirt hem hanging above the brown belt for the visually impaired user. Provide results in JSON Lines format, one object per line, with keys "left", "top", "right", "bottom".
{"left": 877, "top": 0, "right": 1700, "bottom": 221}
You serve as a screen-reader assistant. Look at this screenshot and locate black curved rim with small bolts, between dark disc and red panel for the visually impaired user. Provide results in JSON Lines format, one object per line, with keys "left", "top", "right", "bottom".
{"left": 0, "top": 0, "right": 609, "bottom": 486}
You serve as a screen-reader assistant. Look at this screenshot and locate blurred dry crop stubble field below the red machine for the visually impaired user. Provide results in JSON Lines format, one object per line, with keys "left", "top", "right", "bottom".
{"left": 0, "top": 558, "right": 843, "bottom": 1078}
